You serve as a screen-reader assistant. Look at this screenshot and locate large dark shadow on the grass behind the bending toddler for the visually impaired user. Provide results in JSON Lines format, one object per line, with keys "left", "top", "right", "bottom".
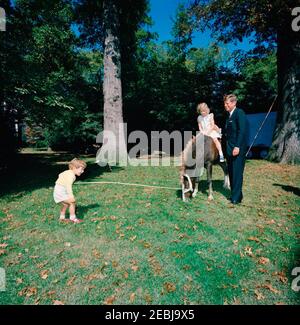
{"left": 0, "top": 153, "right": 122, "bottom": 199}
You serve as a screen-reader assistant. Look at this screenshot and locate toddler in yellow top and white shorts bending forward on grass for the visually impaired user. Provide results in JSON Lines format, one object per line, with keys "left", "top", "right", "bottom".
{"left": 53, "top": 158, "right": 86, "bottom": 223}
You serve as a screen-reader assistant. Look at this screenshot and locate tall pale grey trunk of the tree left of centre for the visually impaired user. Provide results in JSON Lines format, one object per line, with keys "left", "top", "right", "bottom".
{"left": 102, "top": 0, "right": 127, "bottom": 165}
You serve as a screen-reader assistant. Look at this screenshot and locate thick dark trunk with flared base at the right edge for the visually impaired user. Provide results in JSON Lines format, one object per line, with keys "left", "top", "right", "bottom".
{"left": 269, "top": 24, "right": 300, "bottom": 164}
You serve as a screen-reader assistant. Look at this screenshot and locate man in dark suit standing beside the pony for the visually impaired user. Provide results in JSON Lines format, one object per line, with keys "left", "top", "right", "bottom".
{"left": 224, "top": 94, "right": 247, "bottom": 204}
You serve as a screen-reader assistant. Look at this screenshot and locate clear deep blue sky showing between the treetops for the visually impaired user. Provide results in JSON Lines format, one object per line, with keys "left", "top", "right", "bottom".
{"left": 149, "top": 0, "right": 253, "bottom": 51}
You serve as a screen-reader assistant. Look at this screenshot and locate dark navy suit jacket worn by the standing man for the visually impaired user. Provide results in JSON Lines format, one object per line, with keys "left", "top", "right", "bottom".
{"left": 225, "top": 108, "right": 247, "bottom": 156}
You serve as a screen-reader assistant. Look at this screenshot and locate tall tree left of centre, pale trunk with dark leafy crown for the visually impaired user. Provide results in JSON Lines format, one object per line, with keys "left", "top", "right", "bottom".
{"left": 75, "top": 0, "right": 147, "bottom": 162}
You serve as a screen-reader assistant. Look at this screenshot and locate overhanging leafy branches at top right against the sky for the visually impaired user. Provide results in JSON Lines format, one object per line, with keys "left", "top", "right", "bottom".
{"left": 189, "top": 0, "right": 297, "bottom": 46}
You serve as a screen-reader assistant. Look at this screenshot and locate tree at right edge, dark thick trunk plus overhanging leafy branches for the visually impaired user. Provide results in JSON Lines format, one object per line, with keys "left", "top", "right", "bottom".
{"left": 190, "top": 0, "right": 300, "bottom": 163}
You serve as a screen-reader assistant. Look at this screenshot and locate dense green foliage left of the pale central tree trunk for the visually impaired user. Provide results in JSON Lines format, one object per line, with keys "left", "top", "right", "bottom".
{"left": 1, "top": 0, "right": 102, "bottom": 150}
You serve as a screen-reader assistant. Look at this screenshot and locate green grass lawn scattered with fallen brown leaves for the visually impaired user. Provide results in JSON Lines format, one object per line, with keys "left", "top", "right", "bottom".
{"left": 0, "top": 149, "right": 300, "bottom": 304}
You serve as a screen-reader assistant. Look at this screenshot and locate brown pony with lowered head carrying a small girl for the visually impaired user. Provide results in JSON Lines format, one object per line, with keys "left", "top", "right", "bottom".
{"left": 180, "top": 133, "right": 230, "bottom": 201}
